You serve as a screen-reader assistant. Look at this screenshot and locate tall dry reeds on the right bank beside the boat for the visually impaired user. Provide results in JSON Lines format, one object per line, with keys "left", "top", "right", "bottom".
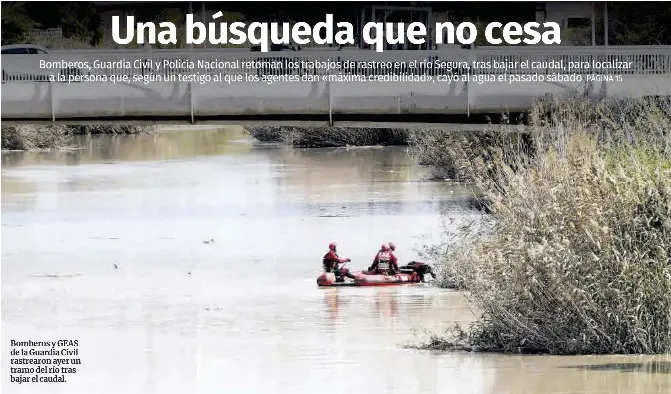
{"left": 422, "top": 99, "right": 671, "bottom": 354}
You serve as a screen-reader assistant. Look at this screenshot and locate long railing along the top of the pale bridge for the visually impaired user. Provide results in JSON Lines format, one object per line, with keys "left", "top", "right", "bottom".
{"left": 2, "top": 46, "right": 671, "bottom": 83}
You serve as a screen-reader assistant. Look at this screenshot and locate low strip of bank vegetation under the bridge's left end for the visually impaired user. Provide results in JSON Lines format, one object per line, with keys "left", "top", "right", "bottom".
{"left": 1, "top": 124, "right": 157, "bottom": 150}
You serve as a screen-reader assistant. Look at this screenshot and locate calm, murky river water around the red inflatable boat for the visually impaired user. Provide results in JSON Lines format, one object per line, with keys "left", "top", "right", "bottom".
{"left": 2, "top": 129, "right": 671, "bottom": 394}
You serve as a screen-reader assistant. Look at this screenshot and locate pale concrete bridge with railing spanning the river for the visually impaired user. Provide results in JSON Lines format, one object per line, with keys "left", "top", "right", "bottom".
{"left": 2, "top": 46, "right": 671, "bottom": 125}
